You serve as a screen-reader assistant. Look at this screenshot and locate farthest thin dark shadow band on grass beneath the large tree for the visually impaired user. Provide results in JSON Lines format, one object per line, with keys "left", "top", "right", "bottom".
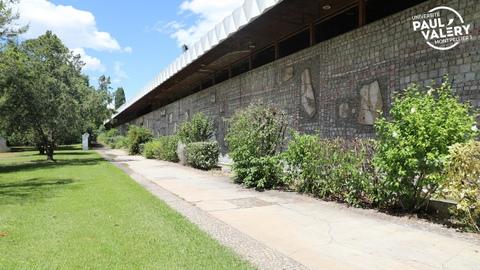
{"left": 0, "top": 158, "right": 105, "bottom": 173}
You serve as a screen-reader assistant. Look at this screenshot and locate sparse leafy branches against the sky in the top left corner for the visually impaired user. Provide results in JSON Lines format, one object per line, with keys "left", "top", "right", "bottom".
{"left": 0, "top": 0, "right": 27, "bottom": 41}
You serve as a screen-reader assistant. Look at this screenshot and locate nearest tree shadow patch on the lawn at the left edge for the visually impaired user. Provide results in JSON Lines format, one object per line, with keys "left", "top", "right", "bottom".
{"left": 0, "top": 178, "right": 74, "bottom": 205}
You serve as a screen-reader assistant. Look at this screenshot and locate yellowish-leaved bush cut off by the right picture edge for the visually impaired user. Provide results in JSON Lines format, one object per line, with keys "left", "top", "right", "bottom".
{"left": 442, "top": 141, "right": 480, "bottom": 231}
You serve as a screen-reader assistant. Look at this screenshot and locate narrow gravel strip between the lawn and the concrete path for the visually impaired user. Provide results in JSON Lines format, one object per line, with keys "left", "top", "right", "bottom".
{"left": 97, "top": 150, "right": 308, "bottom": 270}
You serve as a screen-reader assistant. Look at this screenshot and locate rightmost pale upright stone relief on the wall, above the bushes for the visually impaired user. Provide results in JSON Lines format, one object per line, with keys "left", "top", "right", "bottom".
{"left": 358, "top": 81, "right": 383, "bottom": 125}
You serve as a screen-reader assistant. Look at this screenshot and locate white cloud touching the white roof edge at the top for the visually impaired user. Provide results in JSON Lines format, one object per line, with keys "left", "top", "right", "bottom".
{"left": 167, "top": 0, "right": 243, "bottom": 45}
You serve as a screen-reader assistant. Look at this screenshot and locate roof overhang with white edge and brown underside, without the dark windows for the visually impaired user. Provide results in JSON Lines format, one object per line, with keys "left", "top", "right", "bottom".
{"left": 106, "top": 0, "right": 358, "bottom": 126}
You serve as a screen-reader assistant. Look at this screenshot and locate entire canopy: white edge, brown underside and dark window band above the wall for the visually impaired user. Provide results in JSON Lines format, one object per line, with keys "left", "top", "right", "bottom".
{"left": 105, "top": 0, "right": 404, "bottom": 126}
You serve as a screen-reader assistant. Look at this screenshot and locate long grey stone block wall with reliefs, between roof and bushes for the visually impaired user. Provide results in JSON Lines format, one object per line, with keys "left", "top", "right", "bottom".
{"left": 121, "top": 0, "right": 480, "bottom": 152}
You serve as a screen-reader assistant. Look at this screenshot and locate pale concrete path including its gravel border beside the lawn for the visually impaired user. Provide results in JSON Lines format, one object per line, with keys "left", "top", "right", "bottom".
{"left": 99, "top": 149, "right": 480, "bottom": 270}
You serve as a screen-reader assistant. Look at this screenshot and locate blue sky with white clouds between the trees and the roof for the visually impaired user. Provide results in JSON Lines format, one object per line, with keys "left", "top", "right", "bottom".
{"left": 16, "top": 0, "right": 243, "bottom": 101}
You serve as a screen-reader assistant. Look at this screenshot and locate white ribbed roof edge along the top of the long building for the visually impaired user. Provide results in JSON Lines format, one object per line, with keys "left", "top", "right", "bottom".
{"left": 110, "top": 0, "right": 283, "bottom": 124}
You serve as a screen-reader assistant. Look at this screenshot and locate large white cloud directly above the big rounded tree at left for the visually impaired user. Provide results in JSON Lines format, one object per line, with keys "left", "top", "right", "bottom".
{"left": 18, "top": 0, "right": 122, "bottom": 51}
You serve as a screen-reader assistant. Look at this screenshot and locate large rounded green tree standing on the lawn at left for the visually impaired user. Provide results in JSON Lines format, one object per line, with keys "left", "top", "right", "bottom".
{"left": 0, "top": 32, "right": 110, "bottom": 160}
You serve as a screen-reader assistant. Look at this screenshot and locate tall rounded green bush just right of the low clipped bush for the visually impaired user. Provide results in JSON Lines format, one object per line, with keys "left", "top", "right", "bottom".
{"left": 225, "top": 105, "right": 287, "bottom": 189}
